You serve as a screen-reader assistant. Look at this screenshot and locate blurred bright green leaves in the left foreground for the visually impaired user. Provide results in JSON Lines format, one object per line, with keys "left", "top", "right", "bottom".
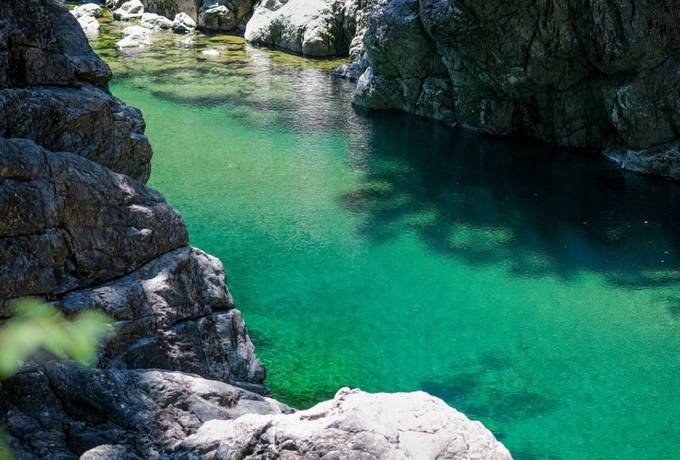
{"left": 0, "top": 299, "right": 113, "bottom": 379}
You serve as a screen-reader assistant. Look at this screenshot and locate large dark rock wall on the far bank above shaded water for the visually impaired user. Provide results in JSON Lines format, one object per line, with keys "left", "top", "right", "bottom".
{"left": 354, "top": 0, "right": 680, "bottom": 178}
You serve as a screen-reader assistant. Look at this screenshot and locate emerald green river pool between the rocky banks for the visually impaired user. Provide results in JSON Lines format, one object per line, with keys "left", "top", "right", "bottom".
{"left": 87, "top": 13, "right": 680, "bottom": 459}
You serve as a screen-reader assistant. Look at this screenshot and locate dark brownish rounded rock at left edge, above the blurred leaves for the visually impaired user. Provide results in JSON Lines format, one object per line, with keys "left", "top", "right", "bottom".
{"left": 0, "top": 139, "right": 188, "bottom": 306}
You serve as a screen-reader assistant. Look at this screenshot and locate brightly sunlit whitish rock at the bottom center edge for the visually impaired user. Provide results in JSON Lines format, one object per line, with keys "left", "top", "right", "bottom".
{"left": 167, "top": 388, "right": 511, "bottom": 460}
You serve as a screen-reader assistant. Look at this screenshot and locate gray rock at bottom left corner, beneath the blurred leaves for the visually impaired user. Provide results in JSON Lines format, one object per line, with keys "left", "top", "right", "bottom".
{"left": 0, "top": 361, "right": 291, "bottom": 460}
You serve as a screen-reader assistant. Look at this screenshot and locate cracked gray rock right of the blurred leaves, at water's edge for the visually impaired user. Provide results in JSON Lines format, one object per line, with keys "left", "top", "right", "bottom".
{"left": 58, "top": 246, "right": 267, "bottom": 393}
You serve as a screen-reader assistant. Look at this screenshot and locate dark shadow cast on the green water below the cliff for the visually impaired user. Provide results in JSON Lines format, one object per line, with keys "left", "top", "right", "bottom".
{"left": 339, "top": 114, "right": 680, "bottom": 288}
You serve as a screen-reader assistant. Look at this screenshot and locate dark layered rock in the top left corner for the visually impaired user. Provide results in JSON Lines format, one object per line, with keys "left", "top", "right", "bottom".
{"left": 0, "top": 0, "right": 151, "bottom": 182}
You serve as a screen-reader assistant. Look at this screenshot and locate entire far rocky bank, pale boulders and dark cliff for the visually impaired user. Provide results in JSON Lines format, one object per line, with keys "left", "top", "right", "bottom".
{"left": 71, "top": 0, "right": 680, "bottom": 179}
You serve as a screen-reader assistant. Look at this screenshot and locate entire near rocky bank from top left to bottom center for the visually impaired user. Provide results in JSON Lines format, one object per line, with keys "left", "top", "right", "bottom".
{"left": 0, "top": 0, "right": 510, "bottom": 460}
